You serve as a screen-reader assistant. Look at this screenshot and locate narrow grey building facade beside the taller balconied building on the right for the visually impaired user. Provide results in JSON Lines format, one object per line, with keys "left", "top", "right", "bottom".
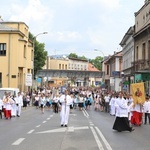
{"left": 120, "top": 26, "right": 134, "bottom": 93}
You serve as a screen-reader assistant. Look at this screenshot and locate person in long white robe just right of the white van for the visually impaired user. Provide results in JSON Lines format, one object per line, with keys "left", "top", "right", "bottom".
{"left": 15, "top": 92, "right": 23, "bottom": 117}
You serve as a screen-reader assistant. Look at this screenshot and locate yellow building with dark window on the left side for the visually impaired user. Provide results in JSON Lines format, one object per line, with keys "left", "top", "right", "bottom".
{"left": 0, "top": 21, "right": 33, "bottom": 91}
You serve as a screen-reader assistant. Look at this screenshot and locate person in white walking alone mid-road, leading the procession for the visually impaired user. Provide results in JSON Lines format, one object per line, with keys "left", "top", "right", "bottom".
{"left": 60, "top": 90, "right": 72, "bottom": 127}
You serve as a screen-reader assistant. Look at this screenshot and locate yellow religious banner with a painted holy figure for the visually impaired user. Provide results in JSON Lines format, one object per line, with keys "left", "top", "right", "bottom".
{"left": 131, "top": 82, "right": 145, "bottom": 104}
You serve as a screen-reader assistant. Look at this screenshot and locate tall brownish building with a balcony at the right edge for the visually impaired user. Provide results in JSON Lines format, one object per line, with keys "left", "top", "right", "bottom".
{"left": 132, "top": 1, "right": 150, "bottom": 94}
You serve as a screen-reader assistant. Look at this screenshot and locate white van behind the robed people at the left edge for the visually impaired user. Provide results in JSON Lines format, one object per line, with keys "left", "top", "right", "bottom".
{"left": 0, "top": 88, "right": 20, "bottom": 99}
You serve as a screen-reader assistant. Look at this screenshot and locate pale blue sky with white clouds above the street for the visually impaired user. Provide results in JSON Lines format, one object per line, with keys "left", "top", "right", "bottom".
{"left": 0, "top": 0, "right": 144, "bottom": 59}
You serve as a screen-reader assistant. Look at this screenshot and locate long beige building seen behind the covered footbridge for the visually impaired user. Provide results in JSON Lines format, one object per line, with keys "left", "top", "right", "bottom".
{"left": 43, "top": 57, "right": 98, "bottom": 86}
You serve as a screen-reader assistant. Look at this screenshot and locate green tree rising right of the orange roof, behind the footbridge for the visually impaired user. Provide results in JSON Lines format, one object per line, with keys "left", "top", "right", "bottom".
{"left": 90, "top": 56, "right": 103, "bottom": 70}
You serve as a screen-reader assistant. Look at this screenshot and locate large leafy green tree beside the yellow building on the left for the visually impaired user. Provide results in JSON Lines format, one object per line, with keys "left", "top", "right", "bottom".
{"left": 29, "top": 33, "right": 48, "bottom": 77}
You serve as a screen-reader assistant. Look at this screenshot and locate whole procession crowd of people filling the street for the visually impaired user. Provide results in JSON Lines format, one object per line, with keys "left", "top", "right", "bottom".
{"left": 0, "top": 87, "right": 150, "bottom": 132}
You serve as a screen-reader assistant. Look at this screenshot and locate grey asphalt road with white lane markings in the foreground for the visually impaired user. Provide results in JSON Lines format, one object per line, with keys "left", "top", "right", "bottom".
{"left": 0, "top": 107, "right": 150, "bottom": 150}
